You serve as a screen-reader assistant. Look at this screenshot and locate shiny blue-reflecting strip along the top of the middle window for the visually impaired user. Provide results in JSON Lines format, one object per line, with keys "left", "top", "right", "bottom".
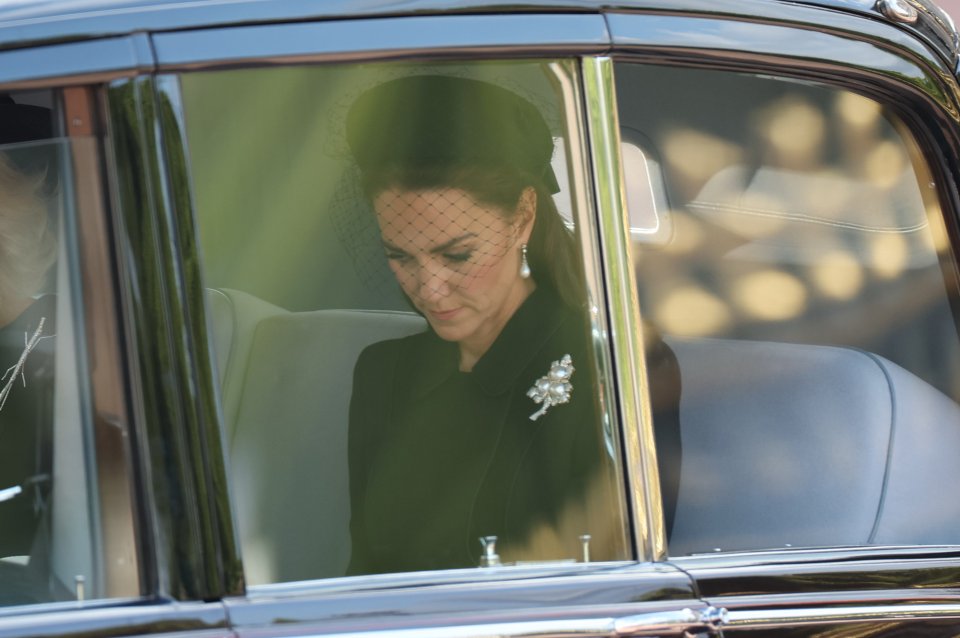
{"left": 152, "top": 14, "right": 610, "bottom": 71}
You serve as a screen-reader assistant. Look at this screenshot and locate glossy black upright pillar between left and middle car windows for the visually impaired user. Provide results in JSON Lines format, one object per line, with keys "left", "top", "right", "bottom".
{"left": 110, "top": 77, "right": 242, "bottom": 600}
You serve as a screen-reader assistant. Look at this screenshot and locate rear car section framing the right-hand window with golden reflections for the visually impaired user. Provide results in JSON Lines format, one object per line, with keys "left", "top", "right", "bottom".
{"left": 608, "top": 4, "right": 960, "bottom": 636}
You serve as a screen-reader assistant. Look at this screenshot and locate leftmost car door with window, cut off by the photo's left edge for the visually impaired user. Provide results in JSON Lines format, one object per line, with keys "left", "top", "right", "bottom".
{"left": 0, "top": 22, "right": 228, "bottom": 636}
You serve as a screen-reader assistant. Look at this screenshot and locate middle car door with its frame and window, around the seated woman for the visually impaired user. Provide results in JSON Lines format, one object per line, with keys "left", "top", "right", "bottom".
{"left": 139, "top": 6, "right": 732, "bottom": 636}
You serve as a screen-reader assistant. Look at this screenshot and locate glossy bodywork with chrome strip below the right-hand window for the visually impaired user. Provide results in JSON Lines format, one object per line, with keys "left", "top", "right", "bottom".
{"left": 676, "top": 547, "right": 960, "bottom": 637}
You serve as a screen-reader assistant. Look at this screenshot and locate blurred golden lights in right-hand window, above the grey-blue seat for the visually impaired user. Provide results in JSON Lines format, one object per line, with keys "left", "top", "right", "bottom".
{"left": 617, "top": 58, "right": 960, "bottom": 399}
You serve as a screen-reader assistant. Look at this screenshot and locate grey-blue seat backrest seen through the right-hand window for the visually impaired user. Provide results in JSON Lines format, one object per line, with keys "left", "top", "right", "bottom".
{"left": 668, "top": 338, "right": 960, "bottom": 555}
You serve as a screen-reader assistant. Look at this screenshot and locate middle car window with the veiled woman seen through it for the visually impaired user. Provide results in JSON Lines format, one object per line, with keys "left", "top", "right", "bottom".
{"left": 181, "top": 61, "right": 630, "bottom": 584}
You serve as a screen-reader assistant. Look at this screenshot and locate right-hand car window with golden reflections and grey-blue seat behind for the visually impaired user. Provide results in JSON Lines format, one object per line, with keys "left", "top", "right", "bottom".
{"left": 616, "top": 63, "right": 960, "bottom": 555}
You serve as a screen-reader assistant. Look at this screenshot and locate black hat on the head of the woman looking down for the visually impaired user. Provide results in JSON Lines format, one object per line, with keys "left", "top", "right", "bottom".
{"left": 346, "top": 75, "right": 559, "bottom": 193}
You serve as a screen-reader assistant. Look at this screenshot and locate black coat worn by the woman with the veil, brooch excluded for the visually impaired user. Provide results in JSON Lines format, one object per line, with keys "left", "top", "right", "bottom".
{"left": 349, "top": 287, "right": 684, "bottom": 574}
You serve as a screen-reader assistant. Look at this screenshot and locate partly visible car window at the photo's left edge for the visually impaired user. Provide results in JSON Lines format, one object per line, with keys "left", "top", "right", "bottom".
{"left": 0, "top": 91, "right": 107, "bottom": 605}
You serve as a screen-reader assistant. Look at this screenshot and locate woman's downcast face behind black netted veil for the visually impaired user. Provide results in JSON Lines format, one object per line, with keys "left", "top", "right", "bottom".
{"left": 374, "top": 188, "right": 536, "bottom": 358}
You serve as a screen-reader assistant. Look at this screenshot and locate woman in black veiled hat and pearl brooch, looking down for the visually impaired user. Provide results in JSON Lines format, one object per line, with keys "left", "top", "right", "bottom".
{"left": 347, "top": 76, "right": 680, "bottom": 573}
